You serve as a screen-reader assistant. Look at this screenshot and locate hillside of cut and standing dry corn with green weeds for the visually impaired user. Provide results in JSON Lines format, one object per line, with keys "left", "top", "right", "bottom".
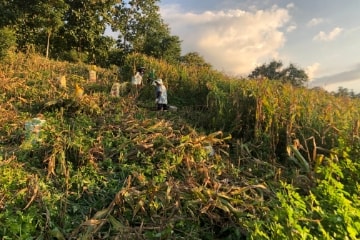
{"left": 0, "top": 54, "right": 360, "bottom": 239}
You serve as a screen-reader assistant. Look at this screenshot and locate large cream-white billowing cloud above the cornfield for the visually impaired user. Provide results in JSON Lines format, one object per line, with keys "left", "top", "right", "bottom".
{"left": 161, "top": 5, "right": 290, "bottom": 74}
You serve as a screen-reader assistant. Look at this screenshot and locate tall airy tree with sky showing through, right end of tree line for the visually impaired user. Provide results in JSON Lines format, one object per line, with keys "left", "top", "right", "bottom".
{"left": 112, "top": 0, "right": 181, "bottom": 62}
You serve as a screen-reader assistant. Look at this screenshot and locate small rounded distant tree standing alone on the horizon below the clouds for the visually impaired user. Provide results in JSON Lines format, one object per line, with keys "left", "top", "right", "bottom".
{"left": 248, "top": 61, "right": 309, "bottom": 86}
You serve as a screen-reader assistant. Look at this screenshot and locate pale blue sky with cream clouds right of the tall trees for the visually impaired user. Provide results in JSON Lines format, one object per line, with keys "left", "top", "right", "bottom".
{"left": 159, "top": 0, "right": 360, "bottom": 93}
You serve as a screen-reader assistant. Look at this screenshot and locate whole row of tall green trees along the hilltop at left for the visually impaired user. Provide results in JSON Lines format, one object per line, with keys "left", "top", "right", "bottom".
{"left": 0, "top": 0, "right": 181, "bottom": 67}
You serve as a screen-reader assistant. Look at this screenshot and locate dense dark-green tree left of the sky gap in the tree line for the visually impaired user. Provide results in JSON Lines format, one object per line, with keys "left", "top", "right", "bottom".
{"left": 57, "top": 0, "right": 120, "bottom": 63}
